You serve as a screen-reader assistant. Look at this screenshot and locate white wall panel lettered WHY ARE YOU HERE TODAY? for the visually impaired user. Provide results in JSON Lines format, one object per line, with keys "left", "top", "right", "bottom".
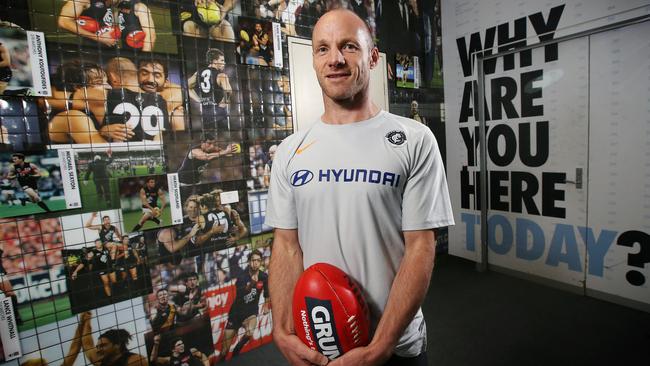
{"left": 442, "top": 0, "right": 650, "bottom": 303}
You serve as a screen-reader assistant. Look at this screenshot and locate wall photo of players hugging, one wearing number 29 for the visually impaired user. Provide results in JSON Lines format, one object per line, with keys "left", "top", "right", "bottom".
{"left": 46, "top": 57, "right": 185, "bottom": 145}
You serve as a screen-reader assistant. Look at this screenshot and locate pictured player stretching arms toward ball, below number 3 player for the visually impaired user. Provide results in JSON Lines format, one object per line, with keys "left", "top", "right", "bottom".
{"left": 177, "top": 133, "right": 236, "bottom": 185}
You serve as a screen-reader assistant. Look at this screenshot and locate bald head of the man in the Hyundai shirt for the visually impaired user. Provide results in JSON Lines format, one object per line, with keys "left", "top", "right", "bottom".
{"left": 312, "top": 9, "right": 379, "bottom": 104}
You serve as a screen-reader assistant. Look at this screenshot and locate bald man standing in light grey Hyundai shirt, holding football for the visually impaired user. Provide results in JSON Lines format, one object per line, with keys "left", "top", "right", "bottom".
{"left": 266, "top": 9, "right": 453, "bottom": 366}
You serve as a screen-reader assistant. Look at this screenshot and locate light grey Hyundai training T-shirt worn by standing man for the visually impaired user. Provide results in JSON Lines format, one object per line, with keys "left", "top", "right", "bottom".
{"left": 266, "top": 111, "right": 454, "bottom": 357}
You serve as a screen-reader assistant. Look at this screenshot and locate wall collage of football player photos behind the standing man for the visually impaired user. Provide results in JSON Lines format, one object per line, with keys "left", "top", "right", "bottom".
{"left": 0, "top": 0, "right": 444, "bottom": 366}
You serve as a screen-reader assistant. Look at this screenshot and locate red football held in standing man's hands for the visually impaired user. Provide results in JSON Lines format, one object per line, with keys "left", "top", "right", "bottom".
{"left": 293, "top": 263, "right": 370, "bottom": 360}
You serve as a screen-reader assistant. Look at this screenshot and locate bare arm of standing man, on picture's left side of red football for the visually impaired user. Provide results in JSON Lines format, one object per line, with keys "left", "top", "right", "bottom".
{"left": 269, "top": 229, "right": 328, "bottom": 365}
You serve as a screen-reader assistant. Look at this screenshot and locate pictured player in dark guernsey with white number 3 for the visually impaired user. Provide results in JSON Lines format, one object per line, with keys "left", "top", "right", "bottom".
{"left": 187, "top": 48, "right": 232, "bottom": 130}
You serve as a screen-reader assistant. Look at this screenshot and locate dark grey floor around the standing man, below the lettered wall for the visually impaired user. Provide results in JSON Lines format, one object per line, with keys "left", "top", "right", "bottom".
{"left": 227, "top": 255, "right": 650, "bottom": 366}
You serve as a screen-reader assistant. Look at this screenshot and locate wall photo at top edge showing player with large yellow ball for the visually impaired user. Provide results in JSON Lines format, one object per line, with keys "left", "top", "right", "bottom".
{"left": 180, "top": 0, "right": 240, "bottom": 42}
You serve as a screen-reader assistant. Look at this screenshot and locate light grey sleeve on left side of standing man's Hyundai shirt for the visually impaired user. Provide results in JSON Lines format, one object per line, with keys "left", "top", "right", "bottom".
{"left": 264, "top": 141, "right": 298, "bottom": 229}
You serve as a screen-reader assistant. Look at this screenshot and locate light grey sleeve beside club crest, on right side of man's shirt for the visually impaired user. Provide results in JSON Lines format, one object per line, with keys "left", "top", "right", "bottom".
{"left": 402, "top": 130, "right": 454, "bottom": 231}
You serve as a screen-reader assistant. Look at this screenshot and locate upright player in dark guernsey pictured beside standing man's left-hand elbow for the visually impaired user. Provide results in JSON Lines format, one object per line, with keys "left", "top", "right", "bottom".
{"left": 220, "top": 250, "right": 268, "bottom": 358}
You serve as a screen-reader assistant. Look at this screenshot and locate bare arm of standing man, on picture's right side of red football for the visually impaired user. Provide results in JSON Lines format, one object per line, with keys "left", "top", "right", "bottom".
{"left": 331, "top": 230, "right": 436, "bottom": 366}
